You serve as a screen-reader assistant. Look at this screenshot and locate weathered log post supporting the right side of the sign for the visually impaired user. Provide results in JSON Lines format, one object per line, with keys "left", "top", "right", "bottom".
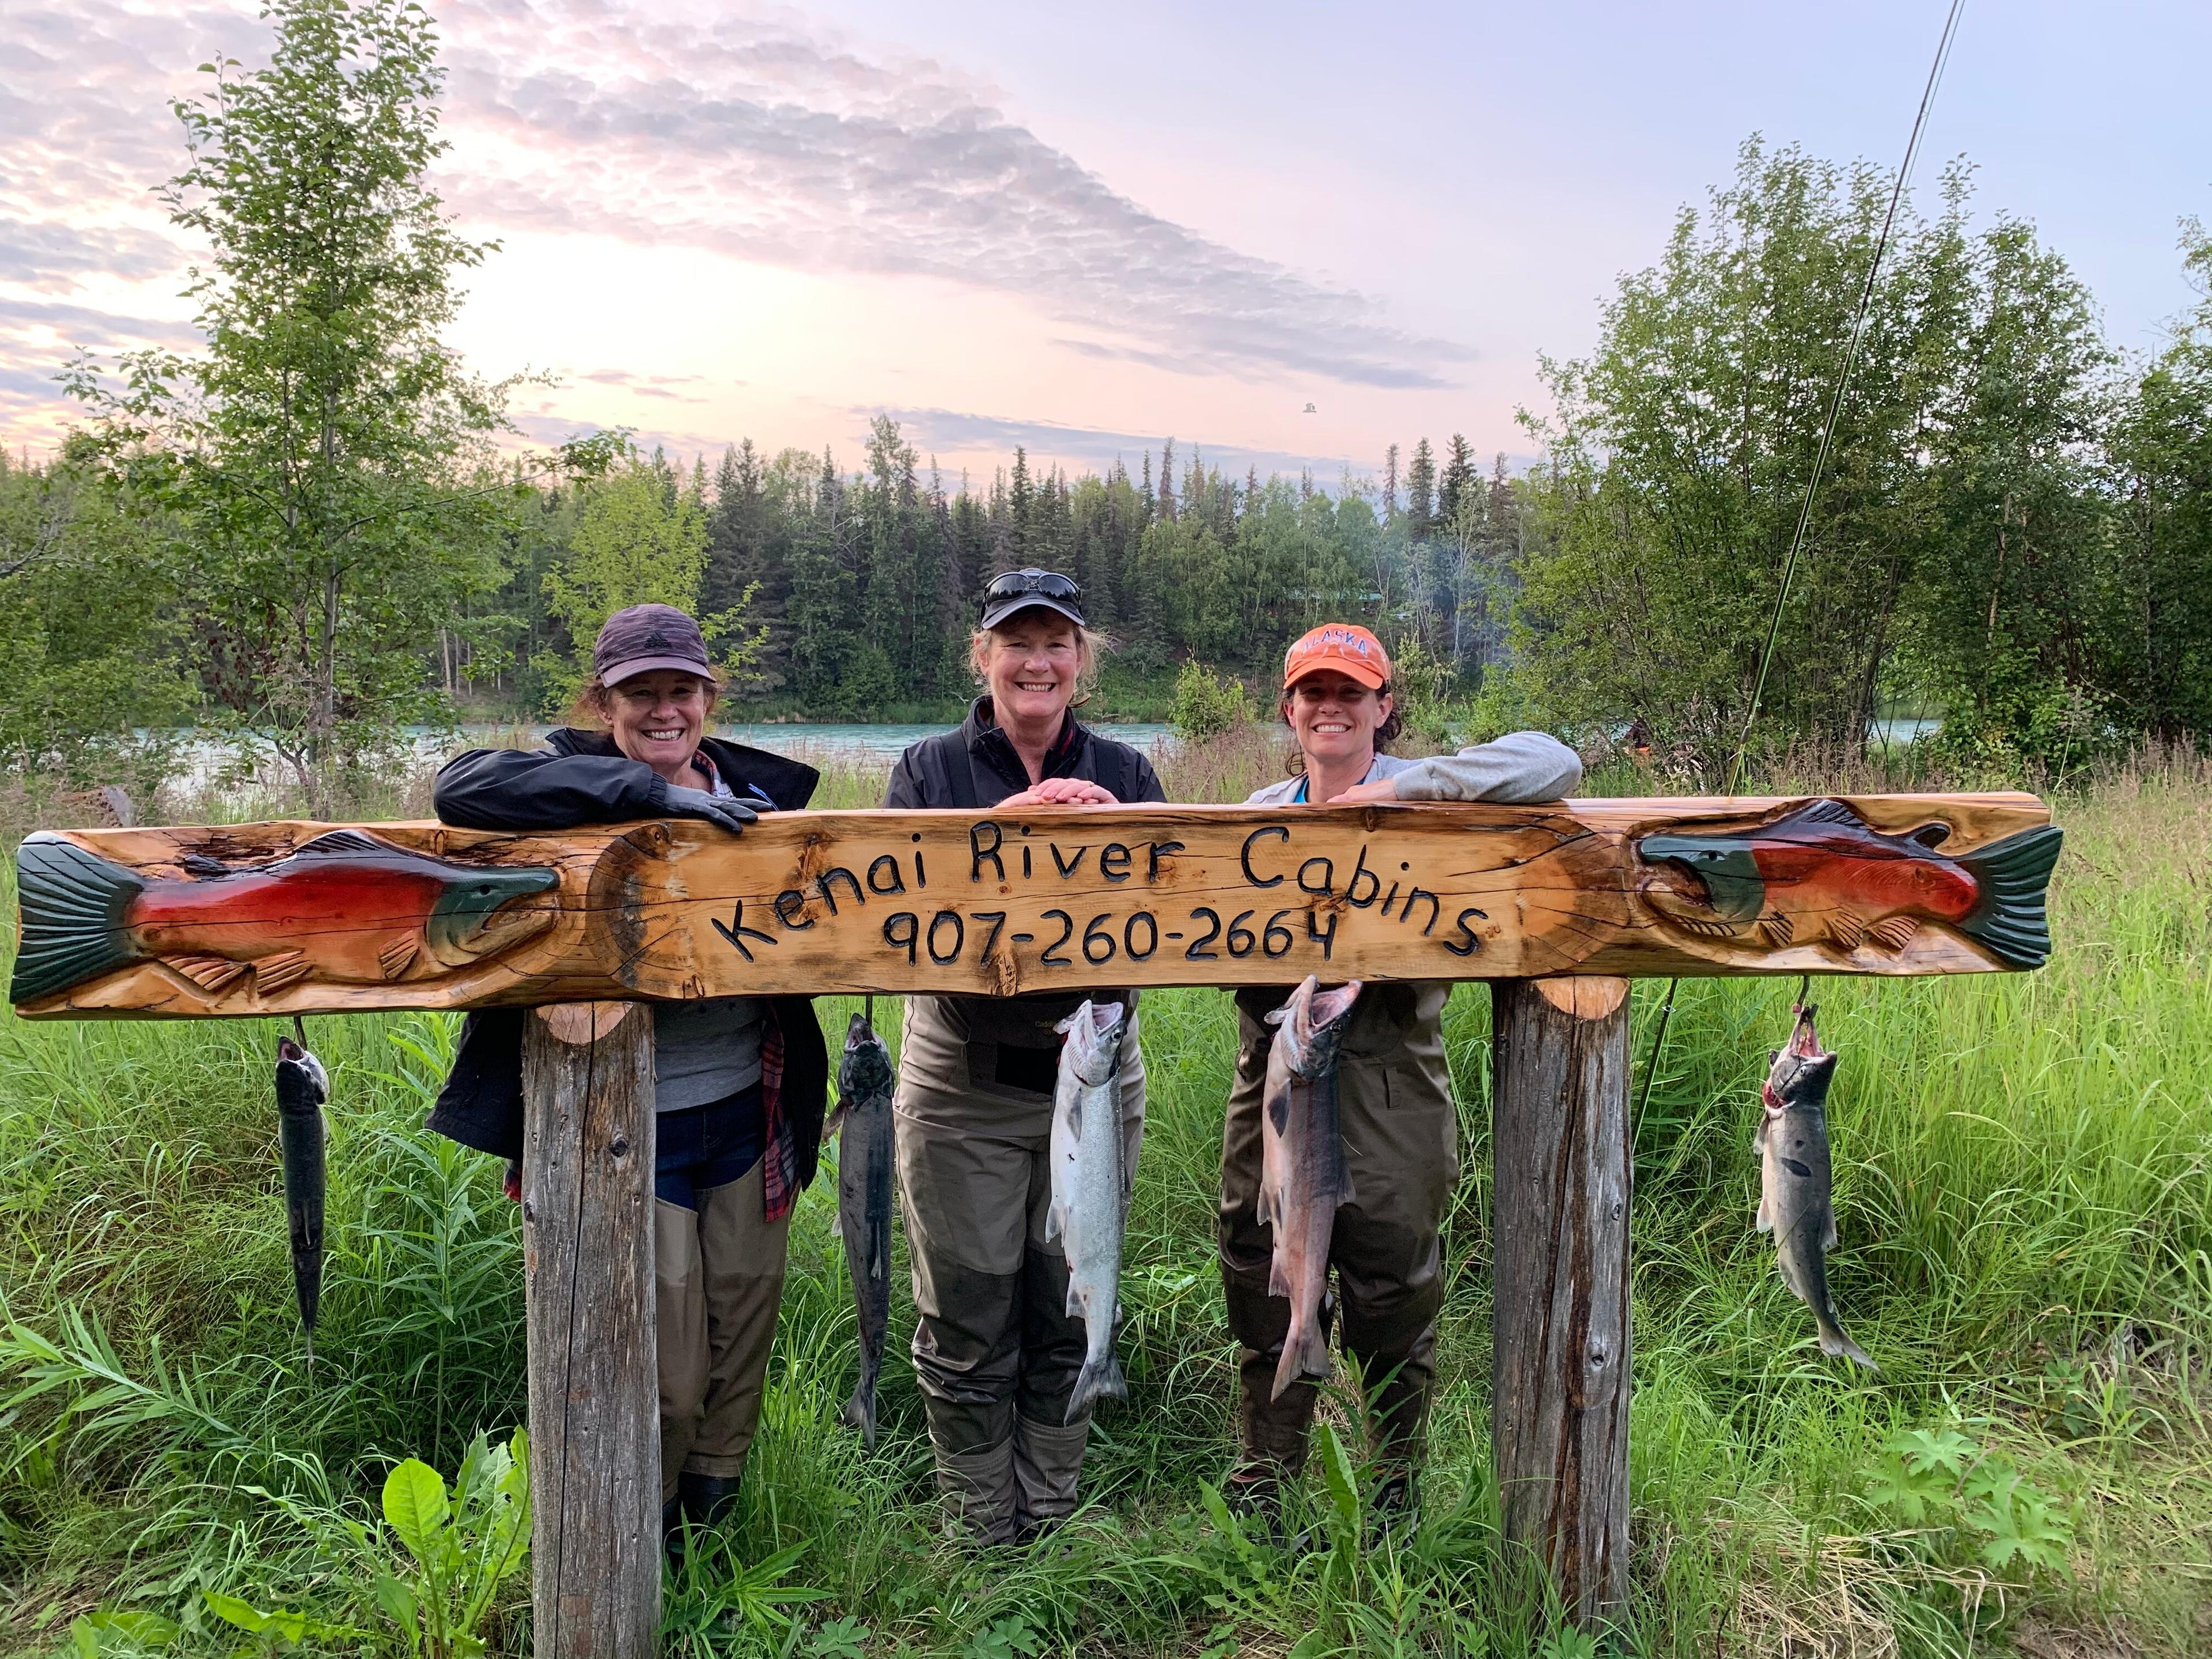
{"left": 1491, "top": 978, "right": 1628, "bottom": 1626}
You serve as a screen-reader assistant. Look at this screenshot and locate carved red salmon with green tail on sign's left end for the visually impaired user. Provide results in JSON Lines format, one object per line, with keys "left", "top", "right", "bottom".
{"left": 9, "top": 830, "right": 560, "bottom": 1002}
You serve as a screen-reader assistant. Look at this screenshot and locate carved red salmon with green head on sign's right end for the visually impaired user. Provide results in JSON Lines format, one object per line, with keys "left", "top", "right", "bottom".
{"left": 1637, "top": 801, "right": 2064, "bottom": 969}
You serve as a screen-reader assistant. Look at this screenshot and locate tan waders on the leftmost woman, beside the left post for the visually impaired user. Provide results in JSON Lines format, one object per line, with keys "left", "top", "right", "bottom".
{"left": 653, "top": 1161, "right": 792, "bottom": 1520}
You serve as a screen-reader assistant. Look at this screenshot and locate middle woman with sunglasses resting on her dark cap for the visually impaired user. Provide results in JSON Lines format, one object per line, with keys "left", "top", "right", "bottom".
{"left": 882, "top": 571, "right": 1166, "bottom": 1544}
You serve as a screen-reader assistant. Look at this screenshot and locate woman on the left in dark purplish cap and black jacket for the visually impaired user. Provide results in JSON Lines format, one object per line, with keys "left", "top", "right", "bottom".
{"left": 429, "top": 604, "right": 830, "bottom": 1528}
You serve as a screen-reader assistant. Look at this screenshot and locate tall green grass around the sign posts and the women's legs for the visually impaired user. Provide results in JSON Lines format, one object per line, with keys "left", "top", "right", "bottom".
{"left": 0, "top": 750, "right": 2212, "bottom": 1659}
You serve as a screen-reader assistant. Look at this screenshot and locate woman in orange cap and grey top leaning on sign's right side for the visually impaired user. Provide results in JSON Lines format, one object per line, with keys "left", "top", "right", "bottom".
{"left": 1221, "top": 622, "right": 1582, "bottom": 1515}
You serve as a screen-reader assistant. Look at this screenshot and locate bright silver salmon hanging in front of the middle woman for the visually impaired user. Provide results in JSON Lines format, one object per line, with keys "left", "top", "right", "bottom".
{"left": 1044, "top": 1002, "right": 1135, "bottom": 1422}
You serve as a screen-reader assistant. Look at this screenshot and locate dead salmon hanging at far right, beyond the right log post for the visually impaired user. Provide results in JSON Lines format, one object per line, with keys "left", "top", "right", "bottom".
{"left": 1754, "top": 1006, "right": 1880, "bottom": 1372}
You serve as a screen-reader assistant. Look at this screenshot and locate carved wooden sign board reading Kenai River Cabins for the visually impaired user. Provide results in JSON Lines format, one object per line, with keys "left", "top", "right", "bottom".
{"left": 13, "top": 794, "right": 2059, "bottom": 1017}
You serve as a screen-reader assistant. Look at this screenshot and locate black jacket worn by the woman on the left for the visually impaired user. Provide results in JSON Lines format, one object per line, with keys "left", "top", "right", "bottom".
{"left": 429, "top": 726, "right": 830, "bottom": 1185}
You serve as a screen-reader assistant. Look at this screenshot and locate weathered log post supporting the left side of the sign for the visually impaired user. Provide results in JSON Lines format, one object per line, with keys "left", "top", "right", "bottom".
{"left": 522, "top": 1002, "right": 661, "bottom": 1659}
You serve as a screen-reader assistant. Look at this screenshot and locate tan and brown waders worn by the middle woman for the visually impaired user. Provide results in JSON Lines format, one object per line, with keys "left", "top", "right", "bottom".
{"left": 892, "top": 995, "right": 1143, "bottom": 1544}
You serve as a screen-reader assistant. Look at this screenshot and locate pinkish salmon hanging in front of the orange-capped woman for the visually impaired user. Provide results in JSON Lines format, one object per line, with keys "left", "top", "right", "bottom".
{"left": 1259, "top": 975, "right": 1361, "bottom": 1398}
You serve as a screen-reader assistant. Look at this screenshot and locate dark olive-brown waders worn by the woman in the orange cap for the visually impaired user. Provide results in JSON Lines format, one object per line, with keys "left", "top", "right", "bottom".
{"left": 1221, "top": 982, "right": 1460, "bottom": 1502}
